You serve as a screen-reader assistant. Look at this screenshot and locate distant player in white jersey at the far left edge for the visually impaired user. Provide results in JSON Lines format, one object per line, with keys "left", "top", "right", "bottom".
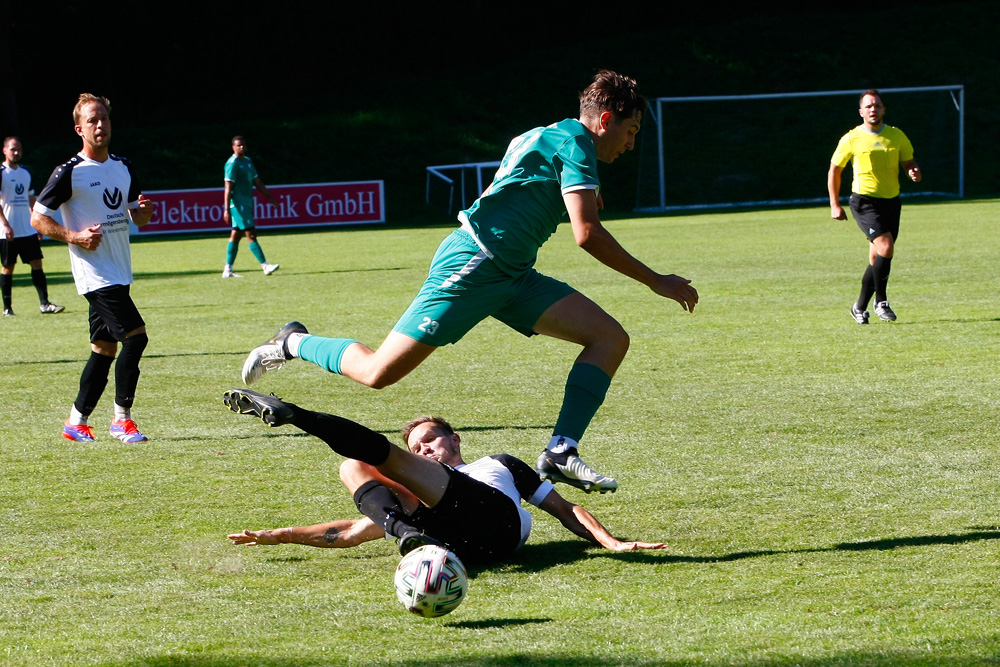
{"left": 0, "top": 137, "right": 65, "bottom": 317}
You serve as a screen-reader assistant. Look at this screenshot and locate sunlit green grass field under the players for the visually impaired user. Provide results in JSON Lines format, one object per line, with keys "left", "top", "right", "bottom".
{"left": 0, "top": 201, "right": 1000, "bottom": 667}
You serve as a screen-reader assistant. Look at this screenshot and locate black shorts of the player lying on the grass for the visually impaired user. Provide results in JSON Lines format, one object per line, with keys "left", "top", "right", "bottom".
{"left": 410, "top": 466, "right": 521, "bottom": 563}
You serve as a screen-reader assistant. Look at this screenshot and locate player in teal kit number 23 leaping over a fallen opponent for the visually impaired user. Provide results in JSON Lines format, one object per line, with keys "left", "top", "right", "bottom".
{"left": 243, "top": 70, "right": 698, "bottom": 492}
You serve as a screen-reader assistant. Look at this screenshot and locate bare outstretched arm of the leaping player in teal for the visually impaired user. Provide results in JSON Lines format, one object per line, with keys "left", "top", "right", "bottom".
{"left": 563, "top": 190, "right": 698, "bottom": 312}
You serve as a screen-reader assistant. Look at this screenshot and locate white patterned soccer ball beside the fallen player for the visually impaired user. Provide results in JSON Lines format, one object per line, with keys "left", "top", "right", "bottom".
{"left": 395, "top": 544, "right": 469, "bottom": 618}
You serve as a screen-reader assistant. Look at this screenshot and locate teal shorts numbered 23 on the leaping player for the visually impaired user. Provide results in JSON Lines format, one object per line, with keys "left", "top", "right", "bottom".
{"left": 393, "top": 229, "right": 576, "bottom": 347}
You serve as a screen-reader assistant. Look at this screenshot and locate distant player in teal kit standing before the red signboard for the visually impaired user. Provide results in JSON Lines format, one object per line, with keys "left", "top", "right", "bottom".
{"left": 222, "top": 136, "right": 278, "bottom": 278}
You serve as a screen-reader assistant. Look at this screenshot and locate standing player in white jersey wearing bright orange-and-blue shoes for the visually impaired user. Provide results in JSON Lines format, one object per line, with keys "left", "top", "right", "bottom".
{"left": 31, "top": 93, "right": 154, "bottom": 442}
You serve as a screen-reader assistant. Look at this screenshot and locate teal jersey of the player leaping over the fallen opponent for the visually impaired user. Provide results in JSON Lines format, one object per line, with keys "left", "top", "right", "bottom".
{"left": 458, "top": 118, "right": 601, "bottom": 274}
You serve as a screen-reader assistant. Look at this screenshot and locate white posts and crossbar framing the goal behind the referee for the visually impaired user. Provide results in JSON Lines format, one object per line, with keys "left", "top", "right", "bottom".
{"left": 635, "top": 85, "right": 965, "bottom": 213}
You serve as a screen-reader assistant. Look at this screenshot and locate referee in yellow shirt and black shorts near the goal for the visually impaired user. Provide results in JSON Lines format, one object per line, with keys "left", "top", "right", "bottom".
{"left": 827, "top": 90, "right": 923, "bottom": 324}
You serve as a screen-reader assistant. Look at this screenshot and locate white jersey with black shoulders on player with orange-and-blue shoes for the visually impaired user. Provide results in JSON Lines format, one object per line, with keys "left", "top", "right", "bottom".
{"left": 34, "top": 153, "right": 140, "bottom": 294}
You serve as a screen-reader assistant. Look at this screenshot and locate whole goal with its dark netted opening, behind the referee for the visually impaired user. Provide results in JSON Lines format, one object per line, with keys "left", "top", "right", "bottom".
{"left": 636, "top": 85, "right": 965, "bottom": 212}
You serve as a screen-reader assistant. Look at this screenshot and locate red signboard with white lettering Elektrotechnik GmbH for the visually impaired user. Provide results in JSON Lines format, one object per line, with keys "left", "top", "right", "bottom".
{"left": 141, "top": 181, "right": 385, "bottom": 234}
